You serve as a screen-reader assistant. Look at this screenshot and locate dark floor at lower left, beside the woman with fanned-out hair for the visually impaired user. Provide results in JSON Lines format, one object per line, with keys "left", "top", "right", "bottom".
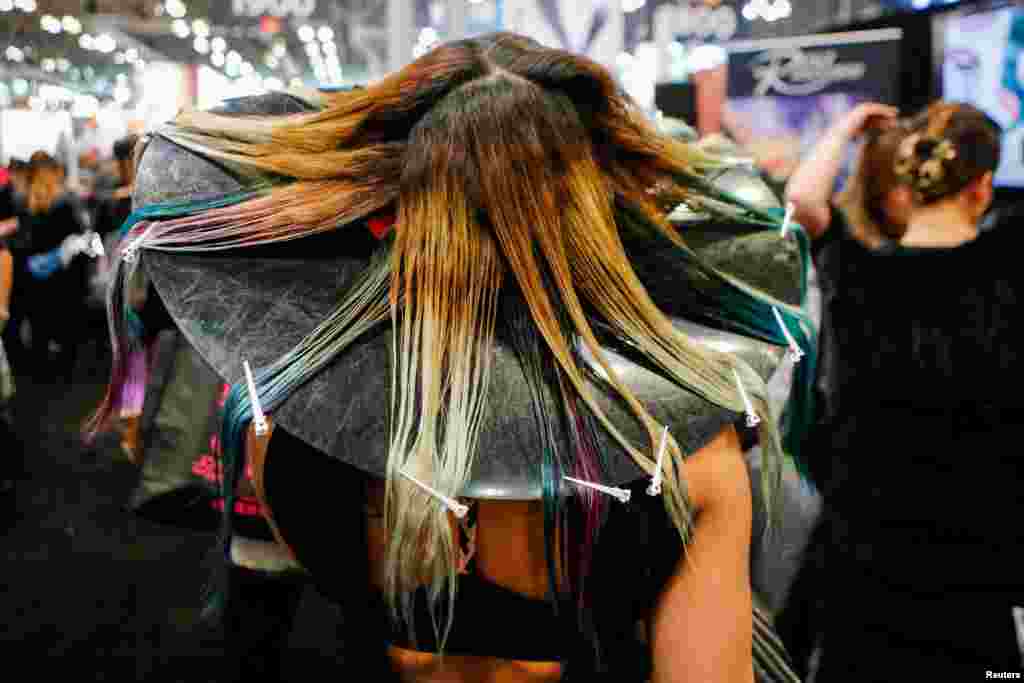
{"left": 0, "top": 352, "right": 340, "bottom": 683}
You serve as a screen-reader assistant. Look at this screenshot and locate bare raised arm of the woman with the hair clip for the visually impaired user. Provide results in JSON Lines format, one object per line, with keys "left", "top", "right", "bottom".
{"left": 785, "top": 102, "right": 898, "bottom": 239}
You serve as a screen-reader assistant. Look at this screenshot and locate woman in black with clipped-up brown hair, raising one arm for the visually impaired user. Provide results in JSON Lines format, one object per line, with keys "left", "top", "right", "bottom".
{"left": 780, "top": 102, "right": 1024, "bottom": 682}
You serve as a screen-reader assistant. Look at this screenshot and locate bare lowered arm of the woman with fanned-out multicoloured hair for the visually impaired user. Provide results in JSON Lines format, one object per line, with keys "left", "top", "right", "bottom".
{"left": 650, "top": 427, "right": 754, "bottom": 683}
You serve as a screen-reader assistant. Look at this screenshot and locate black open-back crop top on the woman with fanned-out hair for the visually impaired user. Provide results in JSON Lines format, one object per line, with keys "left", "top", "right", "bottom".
{"left": 264, "top": 428, "right": 682, "bottom": 682}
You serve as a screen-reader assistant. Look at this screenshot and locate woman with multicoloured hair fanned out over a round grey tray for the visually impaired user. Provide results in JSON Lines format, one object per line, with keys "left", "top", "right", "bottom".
{"left": 97, "top": 34, "right": 813, "bottom": 682}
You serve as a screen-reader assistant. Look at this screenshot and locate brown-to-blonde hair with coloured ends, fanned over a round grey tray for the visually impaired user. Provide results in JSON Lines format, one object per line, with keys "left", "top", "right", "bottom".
{"left": 96, "top": 34, "right": 815, "bottom": 659}
